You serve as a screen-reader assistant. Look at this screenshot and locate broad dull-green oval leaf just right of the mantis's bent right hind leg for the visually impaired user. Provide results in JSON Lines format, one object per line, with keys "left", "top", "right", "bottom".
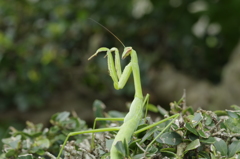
{"left": 156, "top": 132, "right": 182, "bottom": 146}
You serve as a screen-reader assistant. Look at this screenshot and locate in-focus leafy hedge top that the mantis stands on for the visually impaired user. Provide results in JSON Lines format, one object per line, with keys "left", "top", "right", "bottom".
{"left": 0, "top": 100, "right": 240, "bottom": 159}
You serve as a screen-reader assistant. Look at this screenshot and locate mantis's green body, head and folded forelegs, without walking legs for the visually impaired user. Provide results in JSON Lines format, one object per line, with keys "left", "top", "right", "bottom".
{"left": 90, "top": 47, "right": 149, "bottom": 159}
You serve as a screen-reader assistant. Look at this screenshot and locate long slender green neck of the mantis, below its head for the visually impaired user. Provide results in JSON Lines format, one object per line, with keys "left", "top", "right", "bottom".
{"left": 131, "top": 50, "right": 143, "bottom": 99}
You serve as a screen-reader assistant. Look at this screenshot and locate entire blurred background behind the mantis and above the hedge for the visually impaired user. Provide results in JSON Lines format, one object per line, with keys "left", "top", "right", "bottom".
{"left": 0, "top": 0, "right": 240, "bottom": 150}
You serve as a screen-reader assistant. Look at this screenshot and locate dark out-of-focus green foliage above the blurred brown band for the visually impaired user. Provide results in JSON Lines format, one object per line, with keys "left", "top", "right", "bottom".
{"left": 0, "top": 0, "right": 240, "bottom": 111}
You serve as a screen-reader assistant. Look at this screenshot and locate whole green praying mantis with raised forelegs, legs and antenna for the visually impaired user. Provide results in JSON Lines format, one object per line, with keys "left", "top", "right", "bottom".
{"left": 57, "top": 20, "right": 179, "bottom": 159}
